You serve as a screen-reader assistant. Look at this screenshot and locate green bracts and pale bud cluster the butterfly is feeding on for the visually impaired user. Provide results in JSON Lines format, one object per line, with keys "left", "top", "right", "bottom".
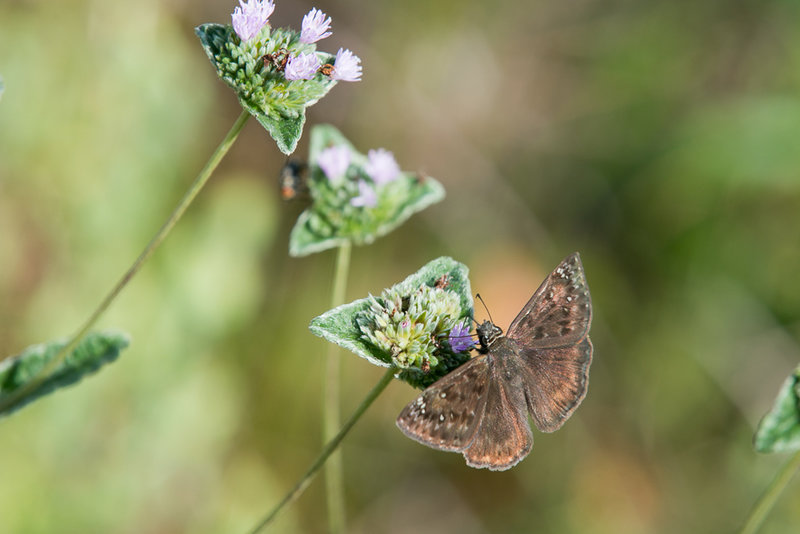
{"left": 309, "top": 257, "right": 473, "bottom": 388}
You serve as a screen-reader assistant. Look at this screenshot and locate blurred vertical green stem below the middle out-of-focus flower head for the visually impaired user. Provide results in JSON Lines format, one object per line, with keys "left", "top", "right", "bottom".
{"left": 322, "top": 242, "right": 352, "bottom": 534}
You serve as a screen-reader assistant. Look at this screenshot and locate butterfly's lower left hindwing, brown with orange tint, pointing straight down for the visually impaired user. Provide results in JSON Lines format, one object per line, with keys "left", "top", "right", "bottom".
{"left": 464, "top": 346, "right": 533, "bottom": 471}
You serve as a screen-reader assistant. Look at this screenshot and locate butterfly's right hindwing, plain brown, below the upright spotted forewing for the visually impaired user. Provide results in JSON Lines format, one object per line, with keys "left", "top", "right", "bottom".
{"left": 519, "top": 336, "right": 592, "bottom": 432}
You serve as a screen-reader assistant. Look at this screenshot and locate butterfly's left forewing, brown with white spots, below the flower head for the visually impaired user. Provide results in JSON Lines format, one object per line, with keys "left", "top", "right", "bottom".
{"left": 397, "top": 356, "right": 489, "bottom": 451}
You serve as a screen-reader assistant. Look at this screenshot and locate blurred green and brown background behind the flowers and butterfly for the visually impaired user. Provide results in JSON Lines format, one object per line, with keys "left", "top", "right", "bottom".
{"left": 0, "top": 0, "right": 800, "bottom": 534}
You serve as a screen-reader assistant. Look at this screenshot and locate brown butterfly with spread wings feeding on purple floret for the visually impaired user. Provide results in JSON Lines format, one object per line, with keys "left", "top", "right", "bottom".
{"left": 397, "top": 252, "right": 592, "bottom": 471}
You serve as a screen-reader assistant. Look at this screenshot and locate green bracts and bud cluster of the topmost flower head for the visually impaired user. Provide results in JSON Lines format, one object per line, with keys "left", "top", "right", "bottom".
{"left": 195, "top": 24, "right": 336, "bottom": 154}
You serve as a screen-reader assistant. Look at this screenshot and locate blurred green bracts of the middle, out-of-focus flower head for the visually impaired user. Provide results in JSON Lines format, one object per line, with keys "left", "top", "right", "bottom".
{"left": 289, "top": 124, "right": 444, "bottom": 256}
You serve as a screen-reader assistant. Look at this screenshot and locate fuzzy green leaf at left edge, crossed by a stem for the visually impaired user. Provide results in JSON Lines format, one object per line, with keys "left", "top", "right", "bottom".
{"left": 0, "top": 332, "right": 130, "bottom": 417}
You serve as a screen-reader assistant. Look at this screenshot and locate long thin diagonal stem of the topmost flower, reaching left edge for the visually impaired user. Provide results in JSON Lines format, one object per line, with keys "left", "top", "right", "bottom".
{"left": 0, "top": 111, "right": 250, "bottom": 412}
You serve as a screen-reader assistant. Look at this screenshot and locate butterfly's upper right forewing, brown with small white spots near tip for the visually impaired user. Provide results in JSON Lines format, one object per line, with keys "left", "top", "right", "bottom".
{"left": 506, "top": 252, "right": 592, "bottom": 348}
